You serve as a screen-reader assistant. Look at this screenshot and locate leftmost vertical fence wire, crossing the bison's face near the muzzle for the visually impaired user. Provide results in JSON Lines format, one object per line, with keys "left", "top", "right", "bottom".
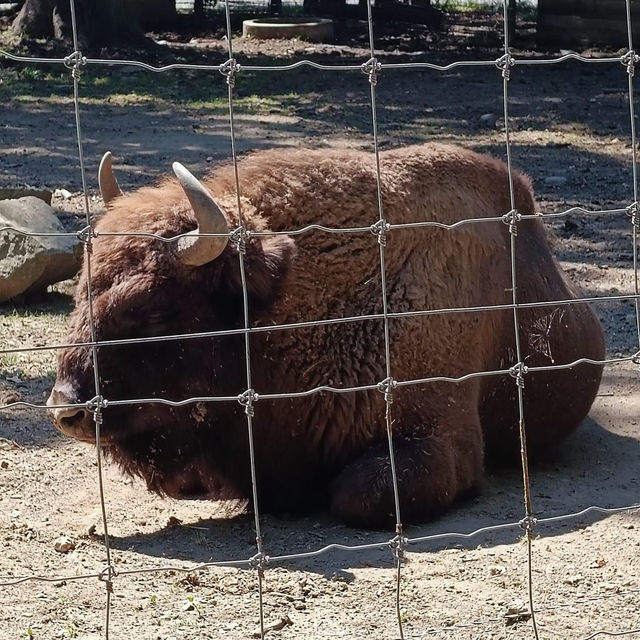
{"left": 69, "top": 0, "right": 115, "bottom": 640}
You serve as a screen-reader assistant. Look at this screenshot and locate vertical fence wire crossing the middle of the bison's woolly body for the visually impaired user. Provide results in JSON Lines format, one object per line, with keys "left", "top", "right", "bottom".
{"left": 363, "top": 0, "right": 405, "bottom": 640}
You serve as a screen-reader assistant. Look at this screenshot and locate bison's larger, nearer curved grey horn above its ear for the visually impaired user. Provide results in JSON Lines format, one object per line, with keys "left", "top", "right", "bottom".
{"left": 173, "top": 162, "right": 229, "bottom": 267}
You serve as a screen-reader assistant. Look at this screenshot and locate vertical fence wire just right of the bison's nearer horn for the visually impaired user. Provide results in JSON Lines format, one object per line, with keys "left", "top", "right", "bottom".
{"left": 221, "top": 2, "right": 266, "bottom": 639}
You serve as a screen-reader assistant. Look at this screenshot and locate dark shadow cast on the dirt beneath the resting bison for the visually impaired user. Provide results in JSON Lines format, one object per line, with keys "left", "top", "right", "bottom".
{"left": 107, "top": 416, "right": 640, "bottom": 579}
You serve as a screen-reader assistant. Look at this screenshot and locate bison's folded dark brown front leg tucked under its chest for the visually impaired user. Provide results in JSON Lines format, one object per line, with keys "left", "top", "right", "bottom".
{"left": 331, "top": 412, "right": 483, "bottom": 527}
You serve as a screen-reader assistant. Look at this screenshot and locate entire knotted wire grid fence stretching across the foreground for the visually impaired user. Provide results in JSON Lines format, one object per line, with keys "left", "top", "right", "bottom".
{"left": 0, "top": 0, "right": 640, "bottom": 640}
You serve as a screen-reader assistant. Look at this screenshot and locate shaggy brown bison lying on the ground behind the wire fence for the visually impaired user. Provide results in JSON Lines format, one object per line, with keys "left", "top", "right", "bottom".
{"left": 48, "top": 144, "right": 604, "bottom": 527}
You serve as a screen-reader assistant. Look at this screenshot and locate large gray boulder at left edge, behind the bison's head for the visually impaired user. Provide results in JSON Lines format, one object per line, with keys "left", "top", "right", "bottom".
{"left": 0, "top": 196, "right": 82, "bottom": 302}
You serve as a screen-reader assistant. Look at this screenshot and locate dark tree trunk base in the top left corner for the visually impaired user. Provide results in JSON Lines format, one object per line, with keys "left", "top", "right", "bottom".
{"left": 13, "top": 0, "right": 175, "bottom": 47}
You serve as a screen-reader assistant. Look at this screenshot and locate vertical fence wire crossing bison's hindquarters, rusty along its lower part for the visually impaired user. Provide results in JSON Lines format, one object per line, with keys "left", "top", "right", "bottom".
{"left": 498, "top": 0, "right": 538, "bottom": 640}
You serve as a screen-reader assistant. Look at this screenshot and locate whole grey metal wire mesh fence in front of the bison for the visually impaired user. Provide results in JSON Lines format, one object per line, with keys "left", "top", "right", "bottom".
{"left": 0, "top": 0, "right": 640, "bottom": 640}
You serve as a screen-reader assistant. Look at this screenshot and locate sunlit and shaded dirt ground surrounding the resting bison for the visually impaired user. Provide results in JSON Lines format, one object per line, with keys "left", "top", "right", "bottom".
{"left": 0, "top": 18, "right": 640, "bottom": 640}
